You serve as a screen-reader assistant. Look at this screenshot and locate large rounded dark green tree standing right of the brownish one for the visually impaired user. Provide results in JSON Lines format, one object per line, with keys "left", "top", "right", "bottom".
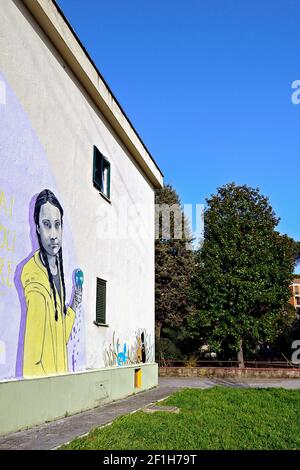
{"left": 190, "top": 183, "right": 297, "bottom": 367}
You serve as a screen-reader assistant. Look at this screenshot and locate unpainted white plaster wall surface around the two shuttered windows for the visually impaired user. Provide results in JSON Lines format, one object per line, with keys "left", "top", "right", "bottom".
{"left": 0, "top": 0, "right": 154, "bottom": 374}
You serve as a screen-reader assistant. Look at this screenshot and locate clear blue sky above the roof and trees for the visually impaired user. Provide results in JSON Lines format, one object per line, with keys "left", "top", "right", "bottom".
{"left": 58, "top": 0, "right": 300, "bottom": 240}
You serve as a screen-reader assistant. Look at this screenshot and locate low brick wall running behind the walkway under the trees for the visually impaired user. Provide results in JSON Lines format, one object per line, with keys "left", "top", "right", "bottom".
{"left": 159, "top": 367, "right": 300, "bottom": 379}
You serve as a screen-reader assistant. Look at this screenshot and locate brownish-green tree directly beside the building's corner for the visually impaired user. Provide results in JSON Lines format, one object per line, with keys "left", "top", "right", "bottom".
{"left": 155, "top": 185, "right": 194, "bottom": 339}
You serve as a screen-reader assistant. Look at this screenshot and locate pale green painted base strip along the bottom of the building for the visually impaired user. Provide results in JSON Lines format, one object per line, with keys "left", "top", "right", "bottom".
{"left": 0, "top": 364, "right": 158, "bottom": 435}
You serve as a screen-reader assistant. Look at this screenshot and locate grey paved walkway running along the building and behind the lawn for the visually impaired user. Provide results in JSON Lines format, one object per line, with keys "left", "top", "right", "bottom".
{"left": 0, "top": 377, "right": 300, "bottom": 450}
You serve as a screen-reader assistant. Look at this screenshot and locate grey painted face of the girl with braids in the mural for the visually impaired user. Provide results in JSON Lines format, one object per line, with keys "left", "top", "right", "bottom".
{"left": 37, "top": 202, "right": 62, "bottom": 256}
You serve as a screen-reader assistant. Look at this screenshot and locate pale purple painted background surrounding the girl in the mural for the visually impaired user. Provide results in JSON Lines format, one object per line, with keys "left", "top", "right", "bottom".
{"left": 0, "top": 73, "right": 85, "bottom": 379}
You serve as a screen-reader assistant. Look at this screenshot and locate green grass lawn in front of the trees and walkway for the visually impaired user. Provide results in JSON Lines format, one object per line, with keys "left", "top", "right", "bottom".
{"left": 58, "top": 387, "right": 300, "bottom": 450}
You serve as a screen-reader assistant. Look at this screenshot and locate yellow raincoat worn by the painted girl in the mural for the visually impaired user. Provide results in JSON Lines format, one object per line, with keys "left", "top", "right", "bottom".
{"left": 21, "top": 251, "right": 75, "bottom": 377}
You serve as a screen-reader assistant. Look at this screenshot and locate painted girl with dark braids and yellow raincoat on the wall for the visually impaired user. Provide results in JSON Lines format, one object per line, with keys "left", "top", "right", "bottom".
{"left": 21, "top": 189, "right": 82, "bottom": 377}
